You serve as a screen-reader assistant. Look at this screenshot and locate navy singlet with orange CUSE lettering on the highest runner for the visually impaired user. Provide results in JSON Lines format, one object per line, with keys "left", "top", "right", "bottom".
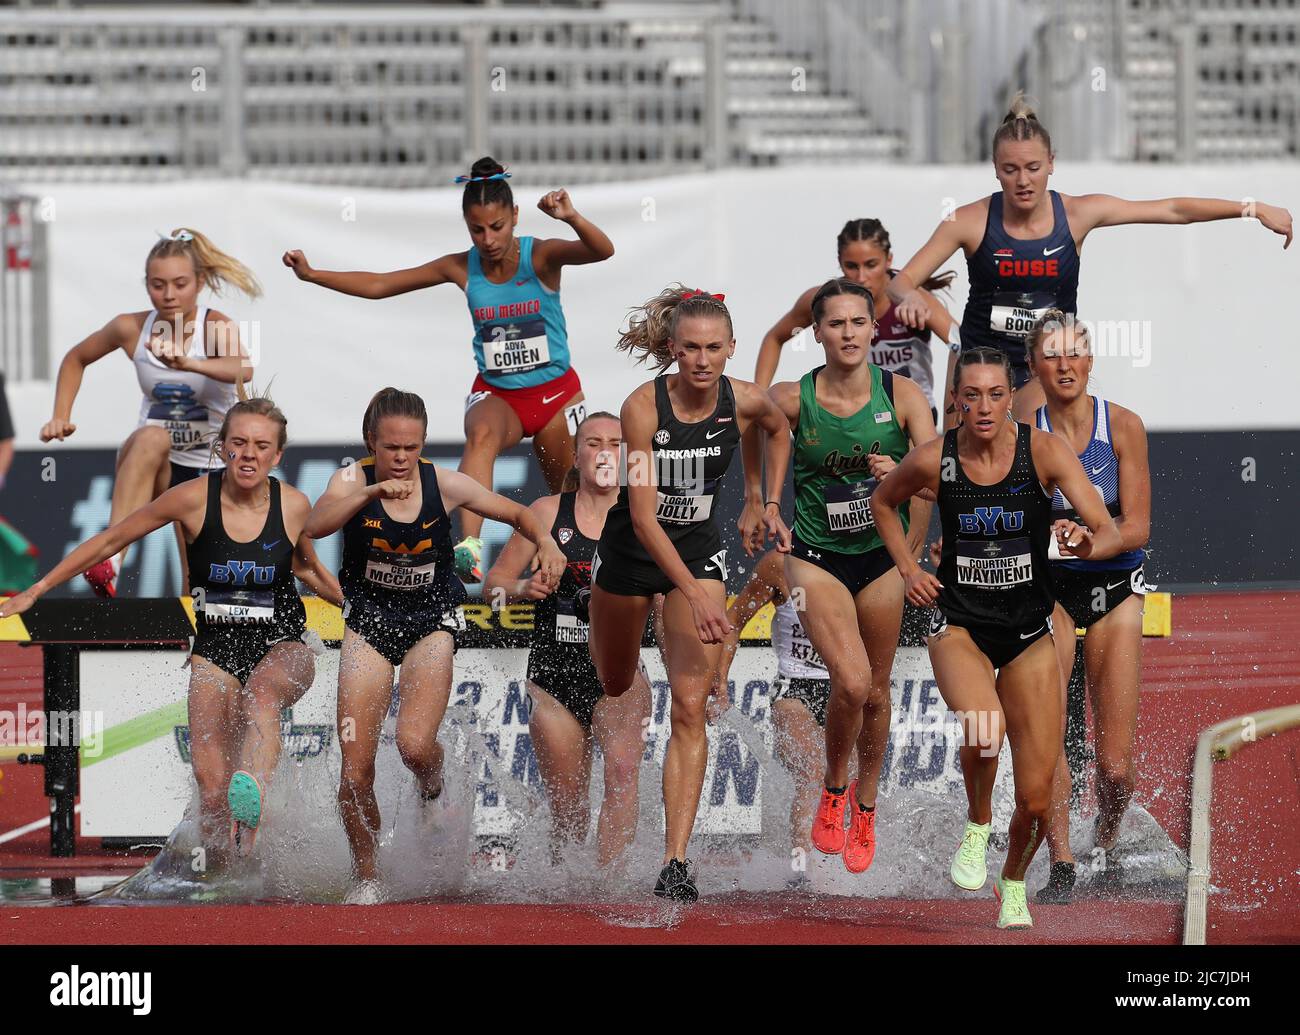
{"left": 962, "top": 191, "right": 1079, "bottom": 367}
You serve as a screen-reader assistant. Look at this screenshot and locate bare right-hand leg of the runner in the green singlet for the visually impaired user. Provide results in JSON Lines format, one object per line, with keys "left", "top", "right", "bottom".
{"left": 852, "top": 568, "right": 904, "bottom": 807}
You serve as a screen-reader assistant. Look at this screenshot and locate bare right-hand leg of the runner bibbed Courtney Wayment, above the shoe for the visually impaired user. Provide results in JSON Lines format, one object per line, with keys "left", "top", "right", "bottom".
{"left": 997, "top": 636, "right": 1063, "bottom": 880}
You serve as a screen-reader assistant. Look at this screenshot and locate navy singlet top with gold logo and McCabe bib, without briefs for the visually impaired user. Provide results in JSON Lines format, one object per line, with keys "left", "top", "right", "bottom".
{"left": 338, "top": 456, "right": 465, "bottom": 618}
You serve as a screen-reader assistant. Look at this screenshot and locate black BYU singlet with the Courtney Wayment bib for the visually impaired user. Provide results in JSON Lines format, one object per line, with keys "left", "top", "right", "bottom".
{"left": 939, "top": 424, "right": 1053, "bottom": 628}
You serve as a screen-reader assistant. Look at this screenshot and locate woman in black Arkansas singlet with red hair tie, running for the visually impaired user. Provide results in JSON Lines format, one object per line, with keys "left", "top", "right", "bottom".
{"left": 592, "top": 285, "right": 790, "bottom": 901}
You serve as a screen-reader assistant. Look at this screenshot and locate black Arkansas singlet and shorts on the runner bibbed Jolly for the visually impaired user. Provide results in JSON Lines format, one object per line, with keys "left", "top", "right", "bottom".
{"left": 592, "top": 374, "right": 740, "bottom": 596}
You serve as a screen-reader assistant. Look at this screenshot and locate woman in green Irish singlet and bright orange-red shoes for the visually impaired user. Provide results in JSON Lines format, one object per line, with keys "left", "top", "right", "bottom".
{"left": 772, "top": 280, "right": 935, "bottom": 874}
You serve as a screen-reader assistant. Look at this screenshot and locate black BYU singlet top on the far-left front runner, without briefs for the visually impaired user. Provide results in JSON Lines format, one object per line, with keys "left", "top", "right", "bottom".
{"left": 186, "top": 471, "right": 307, "bottom": 632}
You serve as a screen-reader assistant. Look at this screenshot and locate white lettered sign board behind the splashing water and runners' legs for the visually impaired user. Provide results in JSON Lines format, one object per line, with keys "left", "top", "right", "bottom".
{"left": 81, "top": 646, "right": 1011, "bottom": 839}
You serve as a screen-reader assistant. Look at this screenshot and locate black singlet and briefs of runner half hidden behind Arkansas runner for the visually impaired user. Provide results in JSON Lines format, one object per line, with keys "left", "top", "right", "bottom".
{"left": 528, "top": 493, "right": 603, "bottom": 729}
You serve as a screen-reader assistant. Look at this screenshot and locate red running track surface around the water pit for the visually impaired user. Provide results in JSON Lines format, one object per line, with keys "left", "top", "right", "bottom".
{"left": 0, "top": 593, "right": 1300, "bottom": 944}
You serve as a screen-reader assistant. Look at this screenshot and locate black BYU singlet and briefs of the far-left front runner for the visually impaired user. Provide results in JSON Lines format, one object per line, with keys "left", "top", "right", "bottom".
{"left": 187, "top": 471, "right": 307, "bottom": 684}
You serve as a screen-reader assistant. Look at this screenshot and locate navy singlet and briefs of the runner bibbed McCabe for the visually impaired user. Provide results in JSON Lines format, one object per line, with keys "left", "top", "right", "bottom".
{"left": 338, "top": 456, "right": 465, "bottom": 666}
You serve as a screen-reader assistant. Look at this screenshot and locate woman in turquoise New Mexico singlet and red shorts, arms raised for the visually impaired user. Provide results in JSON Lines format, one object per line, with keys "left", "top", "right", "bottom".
{"left": 283, "top": 157, "right": 614, "bottom": 583}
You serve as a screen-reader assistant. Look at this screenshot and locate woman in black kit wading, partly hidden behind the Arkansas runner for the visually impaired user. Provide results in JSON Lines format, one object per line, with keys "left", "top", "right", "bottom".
{"left": 484, "top": 412, "right": 650, "bottom": 866}
